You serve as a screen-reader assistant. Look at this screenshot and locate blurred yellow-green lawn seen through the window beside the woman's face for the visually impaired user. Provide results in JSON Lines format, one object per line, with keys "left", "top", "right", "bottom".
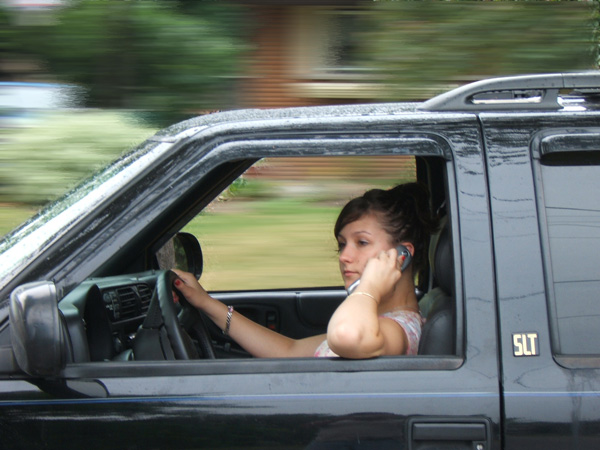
{"left": 184, "top": 199, "right": 342, "bottom": 290}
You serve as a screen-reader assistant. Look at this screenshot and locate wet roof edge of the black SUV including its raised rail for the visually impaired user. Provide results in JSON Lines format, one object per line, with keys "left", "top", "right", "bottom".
{"left": 153, "top": 70, "right": 600, "bottom": 142}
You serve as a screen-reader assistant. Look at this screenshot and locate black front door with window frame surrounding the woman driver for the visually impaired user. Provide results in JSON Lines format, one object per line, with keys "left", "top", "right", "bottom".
{"left": 0, "top": 110, "right": 501, "bottom": 449}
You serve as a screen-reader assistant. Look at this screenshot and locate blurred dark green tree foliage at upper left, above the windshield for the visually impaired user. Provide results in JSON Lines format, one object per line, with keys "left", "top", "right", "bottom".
{"left": 12, "top": 0, "right": 246, "bottom": 126}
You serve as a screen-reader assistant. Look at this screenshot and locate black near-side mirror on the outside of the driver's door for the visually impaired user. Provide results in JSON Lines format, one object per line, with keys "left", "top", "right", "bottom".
{"left": 9, "top": 281, "right": 66, "bottom": 377}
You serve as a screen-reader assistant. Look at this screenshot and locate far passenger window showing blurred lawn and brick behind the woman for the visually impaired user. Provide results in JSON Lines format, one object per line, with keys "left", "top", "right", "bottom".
{"left": 183, "top": 156, "right": 416, "bottom": 291}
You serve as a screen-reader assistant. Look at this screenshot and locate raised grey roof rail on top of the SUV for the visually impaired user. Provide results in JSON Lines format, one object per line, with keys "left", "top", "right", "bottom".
{"left": 419, "top": 71, "right": 600, "bottom": 111}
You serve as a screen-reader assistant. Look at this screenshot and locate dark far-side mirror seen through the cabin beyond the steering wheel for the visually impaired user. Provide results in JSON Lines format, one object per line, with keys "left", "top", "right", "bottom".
{"left": 156, "top": 233, "right": 204, "bottom": 279}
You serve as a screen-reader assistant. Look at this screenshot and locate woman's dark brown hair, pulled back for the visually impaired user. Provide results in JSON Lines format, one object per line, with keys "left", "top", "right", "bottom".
{"left": 333, "top": 182, "right": 438, "bottom": 274}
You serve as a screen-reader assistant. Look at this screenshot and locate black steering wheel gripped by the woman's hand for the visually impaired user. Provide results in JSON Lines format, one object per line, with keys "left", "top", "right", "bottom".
{"left": 133, "top": 270, "right": 215, "bottom": 360}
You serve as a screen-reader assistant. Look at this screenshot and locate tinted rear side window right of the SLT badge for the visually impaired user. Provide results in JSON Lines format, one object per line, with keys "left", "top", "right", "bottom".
{"left": 538, "top": 152, "right": 600, "bottom": 355}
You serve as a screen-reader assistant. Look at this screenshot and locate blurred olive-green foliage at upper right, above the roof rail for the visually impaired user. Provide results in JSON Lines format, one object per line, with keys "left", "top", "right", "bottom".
{"left": 360, "top": 1, "right": 599, "bottom": 100}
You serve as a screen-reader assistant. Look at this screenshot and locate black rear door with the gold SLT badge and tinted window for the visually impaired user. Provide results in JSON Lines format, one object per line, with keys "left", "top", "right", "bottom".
{"left": 483, "top": 112, "right": 600, "bottom": 449}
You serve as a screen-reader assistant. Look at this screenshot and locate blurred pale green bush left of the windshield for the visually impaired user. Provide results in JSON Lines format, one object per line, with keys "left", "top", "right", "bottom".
{"left": 0, "top": 110, "right": 154, "bottom": 205}
